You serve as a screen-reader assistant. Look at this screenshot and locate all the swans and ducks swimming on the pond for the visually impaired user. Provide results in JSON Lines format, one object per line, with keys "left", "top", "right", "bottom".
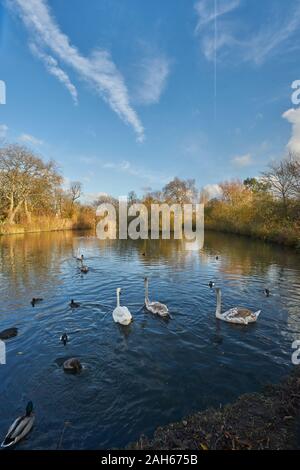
{"left": 0, "top": 253, "right": 270, "bottom": 448}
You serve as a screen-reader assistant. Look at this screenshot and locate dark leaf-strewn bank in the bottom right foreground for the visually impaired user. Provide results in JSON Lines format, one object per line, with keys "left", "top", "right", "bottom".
{"left": 129, "top": 368, "right": 300, "bottom": 450}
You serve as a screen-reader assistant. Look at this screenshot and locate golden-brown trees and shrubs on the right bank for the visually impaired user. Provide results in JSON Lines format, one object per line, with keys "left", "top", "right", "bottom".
{"left": 203, "top": 154, "right": 300, "bottom": 248}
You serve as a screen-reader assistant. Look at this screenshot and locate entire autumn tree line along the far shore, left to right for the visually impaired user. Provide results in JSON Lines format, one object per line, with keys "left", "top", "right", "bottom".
{"left": 0, "top": 145, "right": 300, "bottom": 245}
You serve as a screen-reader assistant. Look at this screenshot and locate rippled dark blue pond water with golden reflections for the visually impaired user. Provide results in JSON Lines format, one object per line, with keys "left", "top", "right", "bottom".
{"left": 0, "top": 232, "right": 300, "bottom": 449}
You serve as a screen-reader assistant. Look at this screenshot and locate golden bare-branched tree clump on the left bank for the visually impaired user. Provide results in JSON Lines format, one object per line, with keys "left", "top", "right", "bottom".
{"left": 0, "top": 145, "right": 92, "bottom": 229}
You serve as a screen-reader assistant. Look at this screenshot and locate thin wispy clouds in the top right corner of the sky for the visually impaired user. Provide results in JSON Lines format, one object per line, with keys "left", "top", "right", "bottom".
{"left": 195, "top": 0, "right": 300, "bottom": 65}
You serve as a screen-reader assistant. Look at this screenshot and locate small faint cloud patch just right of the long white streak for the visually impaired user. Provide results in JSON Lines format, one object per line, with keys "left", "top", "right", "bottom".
{"left": 135, "top": 56, "right": 170, "bottom": 104}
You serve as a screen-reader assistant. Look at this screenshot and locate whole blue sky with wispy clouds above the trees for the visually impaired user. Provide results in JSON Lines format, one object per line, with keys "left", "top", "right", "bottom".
{"left": 0, "top": 0, "right": 300, "bottom": 196}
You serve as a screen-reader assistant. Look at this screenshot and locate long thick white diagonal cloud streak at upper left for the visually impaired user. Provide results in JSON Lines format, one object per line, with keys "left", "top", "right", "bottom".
{"left": 10, "top": 0, "right": 144, "bottom": 141}
